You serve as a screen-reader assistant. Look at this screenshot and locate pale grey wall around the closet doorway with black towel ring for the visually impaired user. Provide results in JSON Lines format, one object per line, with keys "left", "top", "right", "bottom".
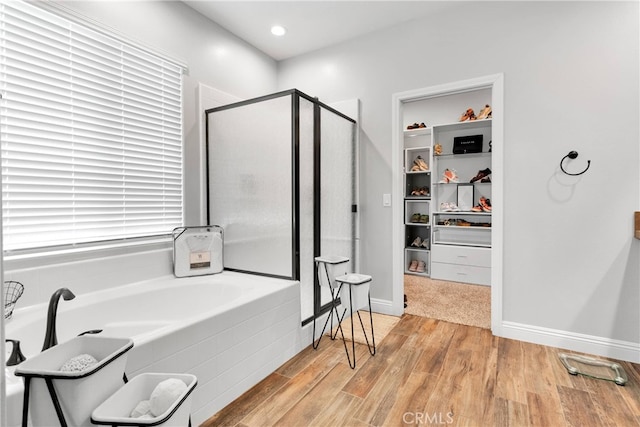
{"left": 278, "top": 2, "right": 640, "bottom": 358}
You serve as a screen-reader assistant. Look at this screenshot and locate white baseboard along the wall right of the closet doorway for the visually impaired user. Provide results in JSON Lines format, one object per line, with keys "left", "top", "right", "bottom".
{"left": 501, "top": 322, "right": 640, "bottom": 363}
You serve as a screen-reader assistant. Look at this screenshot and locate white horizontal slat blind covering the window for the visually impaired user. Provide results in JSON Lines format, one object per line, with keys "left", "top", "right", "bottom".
{"left": 0, "top": 1, "right": 182, "bottom": 250}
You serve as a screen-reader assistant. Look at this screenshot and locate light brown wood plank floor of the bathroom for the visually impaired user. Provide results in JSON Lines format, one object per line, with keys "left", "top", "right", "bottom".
{"left": 202, "top": 314, "right": 640, "bottom": 427}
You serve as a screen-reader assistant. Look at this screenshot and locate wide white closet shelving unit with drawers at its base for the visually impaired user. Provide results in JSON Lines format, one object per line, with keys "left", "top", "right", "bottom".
{"left": 430, "top": 119, "right": 492, "bottom": 285}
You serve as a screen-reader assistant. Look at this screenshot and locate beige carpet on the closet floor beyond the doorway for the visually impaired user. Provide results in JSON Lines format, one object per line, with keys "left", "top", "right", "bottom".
{"left": 404, "top": 274, "right": 491, "bottom": 329}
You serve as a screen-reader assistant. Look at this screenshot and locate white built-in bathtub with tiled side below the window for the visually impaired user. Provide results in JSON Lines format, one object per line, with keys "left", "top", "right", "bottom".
{"left": 5, "top": 271, "right": 304, "bottom": 427}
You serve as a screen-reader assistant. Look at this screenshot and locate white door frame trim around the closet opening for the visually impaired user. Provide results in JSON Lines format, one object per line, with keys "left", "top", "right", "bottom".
{"left": 391, "top": 73, "right": 504, "bottom": 336}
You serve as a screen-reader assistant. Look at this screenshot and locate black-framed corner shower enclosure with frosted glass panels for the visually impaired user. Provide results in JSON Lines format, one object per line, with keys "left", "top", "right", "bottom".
{"left": 205, "top": 89, "right": 357, "bottom": 324}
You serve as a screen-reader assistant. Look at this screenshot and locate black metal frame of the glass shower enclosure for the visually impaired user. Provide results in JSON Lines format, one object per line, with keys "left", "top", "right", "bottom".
{"left": 205, "top": 89, "right": 357, "bottom": 326}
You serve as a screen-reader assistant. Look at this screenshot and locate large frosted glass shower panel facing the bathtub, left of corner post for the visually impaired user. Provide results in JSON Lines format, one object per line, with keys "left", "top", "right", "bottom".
{"left": 208, "top": 97, "right": 293, "bottom": 278}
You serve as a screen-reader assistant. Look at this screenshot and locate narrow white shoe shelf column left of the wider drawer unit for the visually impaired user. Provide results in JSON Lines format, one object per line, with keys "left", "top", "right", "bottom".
{"left": 404, "top": 128, "right": 432, "bottom": 276}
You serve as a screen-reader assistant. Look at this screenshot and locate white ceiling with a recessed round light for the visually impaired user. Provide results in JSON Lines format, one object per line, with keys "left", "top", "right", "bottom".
{"left": 182, "top": 0, "right": 446, "bottom": 61}
